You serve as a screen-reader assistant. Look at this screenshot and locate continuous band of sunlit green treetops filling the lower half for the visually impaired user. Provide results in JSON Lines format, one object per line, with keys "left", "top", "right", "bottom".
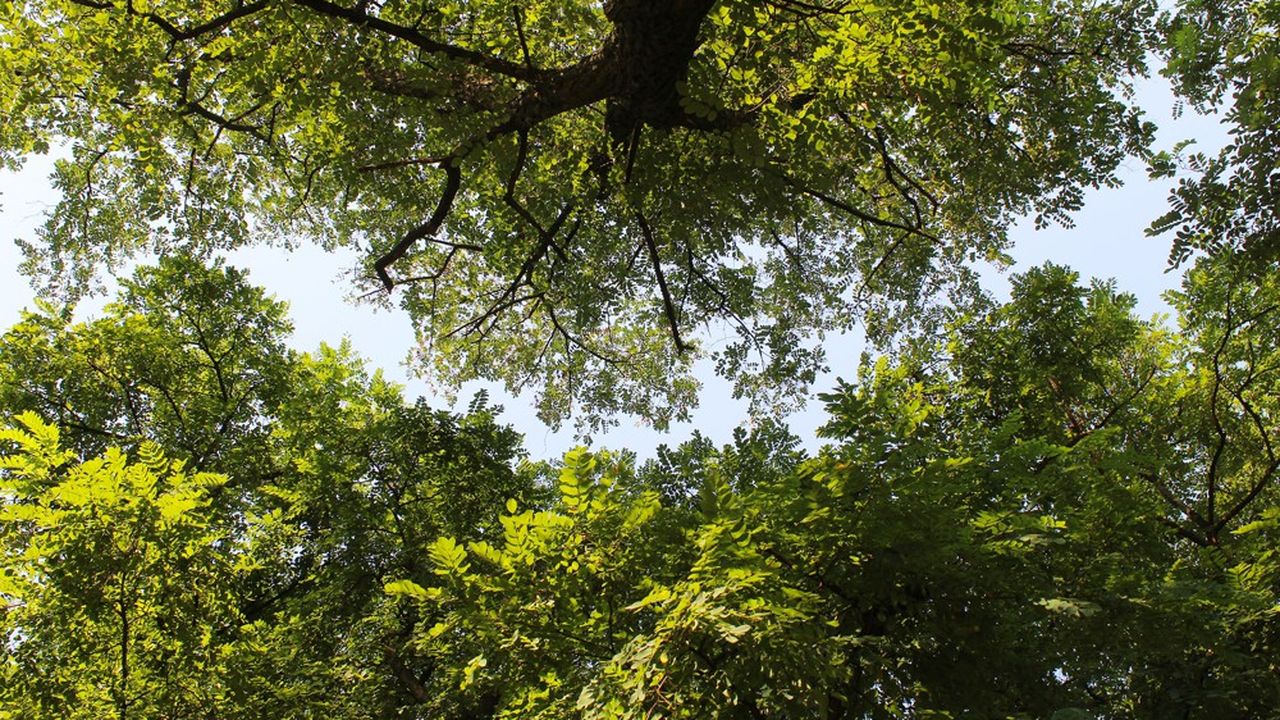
{"left": 0, "top": 254, "right": 1280, "bottom": 720}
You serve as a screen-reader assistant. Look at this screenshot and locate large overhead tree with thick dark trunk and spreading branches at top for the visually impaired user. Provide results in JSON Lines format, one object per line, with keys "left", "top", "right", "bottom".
{"left": 0, "top": 0, "right": 1153, "bottom": 427}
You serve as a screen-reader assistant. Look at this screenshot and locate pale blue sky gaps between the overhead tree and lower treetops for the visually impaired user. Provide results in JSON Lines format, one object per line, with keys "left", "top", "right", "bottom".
{"left": 0, "top": 78, "right": 1225, "bottom": 459}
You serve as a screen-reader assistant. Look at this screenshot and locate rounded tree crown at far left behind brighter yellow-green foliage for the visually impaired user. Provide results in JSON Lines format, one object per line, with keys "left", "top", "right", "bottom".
{"left": 0, "top": 256, "right": 298, "bottom": 486}
